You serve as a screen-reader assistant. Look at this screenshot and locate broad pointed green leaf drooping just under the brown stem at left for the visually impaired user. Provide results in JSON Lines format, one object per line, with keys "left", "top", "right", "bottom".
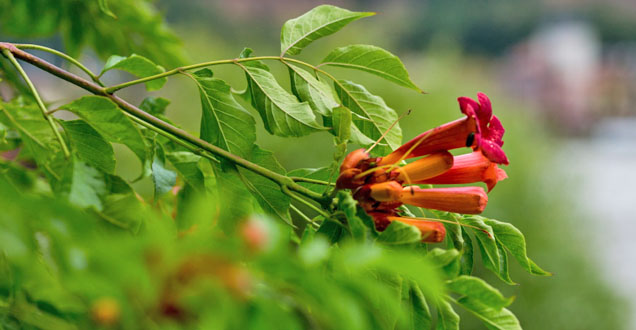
{"left": 60, "top": 96, "right": 150, "bottom": 169}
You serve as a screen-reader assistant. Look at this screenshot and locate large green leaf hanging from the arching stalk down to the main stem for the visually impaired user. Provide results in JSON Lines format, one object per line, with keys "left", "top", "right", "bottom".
{"left": 194, "top": 70, "right": 256, "bottom": 158}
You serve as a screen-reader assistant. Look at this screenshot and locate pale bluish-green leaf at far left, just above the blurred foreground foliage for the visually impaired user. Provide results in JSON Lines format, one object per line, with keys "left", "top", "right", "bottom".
{"left": 56, "top": 159, "right": 106, "bottom": 211}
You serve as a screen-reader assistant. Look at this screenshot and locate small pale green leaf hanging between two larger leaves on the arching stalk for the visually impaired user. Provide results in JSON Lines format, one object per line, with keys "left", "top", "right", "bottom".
{"left": 287, "top": 63, "right": 339, "bottom": 116}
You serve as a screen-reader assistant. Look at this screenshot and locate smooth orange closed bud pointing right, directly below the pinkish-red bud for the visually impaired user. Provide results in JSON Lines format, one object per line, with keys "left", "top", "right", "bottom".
{"left": 400, "top": 187, "right": 488, "bottom": 214}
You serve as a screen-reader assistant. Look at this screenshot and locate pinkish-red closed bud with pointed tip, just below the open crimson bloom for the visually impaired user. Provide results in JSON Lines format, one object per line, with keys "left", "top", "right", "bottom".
{"left": 413, "top": 151, "right": 508, "bottom": 192}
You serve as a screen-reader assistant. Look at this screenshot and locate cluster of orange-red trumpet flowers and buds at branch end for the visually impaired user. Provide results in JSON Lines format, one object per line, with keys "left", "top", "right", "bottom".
{"left": 336, "top": 93, "right": 508, "bottom": 243}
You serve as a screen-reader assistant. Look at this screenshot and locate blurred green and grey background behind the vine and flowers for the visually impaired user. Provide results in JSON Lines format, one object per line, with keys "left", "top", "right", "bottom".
{"left": 0, "top": 0, "right": 636, "bottom": 329}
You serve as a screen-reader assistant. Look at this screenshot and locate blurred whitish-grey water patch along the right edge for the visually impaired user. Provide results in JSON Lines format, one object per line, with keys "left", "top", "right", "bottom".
{"left": 557, "top": 118, "right": 636, "bottom": 329}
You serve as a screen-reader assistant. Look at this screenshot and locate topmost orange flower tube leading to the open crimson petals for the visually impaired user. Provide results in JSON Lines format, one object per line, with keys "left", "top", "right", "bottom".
{"left": 378, "top": 105, "right": 479, "bottom": 166}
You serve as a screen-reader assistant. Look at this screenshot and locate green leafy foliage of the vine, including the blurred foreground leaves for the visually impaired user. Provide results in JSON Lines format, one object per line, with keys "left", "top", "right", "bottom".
{"left": 0, "top": 1, "right": 549, "bottom": 329}
